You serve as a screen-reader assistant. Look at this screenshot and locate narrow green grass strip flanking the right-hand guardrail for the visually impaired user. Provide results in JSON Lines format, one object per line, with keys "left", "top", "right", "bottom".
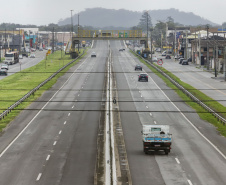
{"left": 130, "top": 51, "right": 226, "bottom": 137}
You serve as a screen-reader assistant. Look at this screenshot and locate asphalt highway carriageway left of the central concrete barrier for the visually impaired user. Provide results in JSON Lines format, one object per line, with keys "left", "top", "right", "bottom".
{"left": 0, "top": 41, "right": 108, "bottom": 185}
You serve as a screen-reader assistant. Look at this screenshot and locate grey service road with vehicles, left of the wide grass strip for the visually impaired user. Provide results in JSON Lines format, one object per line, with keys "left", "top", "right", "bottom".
{"left": 0, "top": 50, "right": 46, "bottom": 80}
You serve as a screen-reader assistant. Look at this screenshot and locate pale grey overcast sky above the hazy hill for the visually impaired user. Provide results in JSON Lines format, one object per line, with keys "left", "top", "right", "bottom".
{"left": 0, "top": 0, "right": 226, "bottom": 26}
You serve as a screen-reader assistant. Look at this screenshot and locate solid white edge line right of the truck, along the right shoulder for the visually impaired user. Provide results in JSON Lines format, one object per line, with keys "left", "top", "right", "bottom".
{"left": 150, "top": 77, "right": 226, "bottom": 159}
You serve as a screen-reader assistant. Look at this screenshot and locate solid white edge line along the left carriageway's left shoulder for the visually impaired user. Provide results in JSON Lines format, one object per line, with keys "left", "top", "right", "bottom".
{"left": 0, "top": 53, "right": 88, "bottom": 157}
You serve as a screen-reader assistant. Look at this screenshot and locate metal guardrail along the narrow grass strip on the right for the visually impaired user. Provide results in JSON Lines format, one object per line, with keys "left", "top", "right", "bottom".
{"left": 130, "top": 49, "right": 226, "bottom": 125}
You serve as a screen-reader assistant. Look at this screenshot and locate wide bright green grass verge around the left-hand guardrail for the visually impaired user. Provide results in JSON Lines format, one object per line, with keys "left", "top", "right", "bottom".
{"left": 0, "top": 51, "right": 86, "bottom": 131}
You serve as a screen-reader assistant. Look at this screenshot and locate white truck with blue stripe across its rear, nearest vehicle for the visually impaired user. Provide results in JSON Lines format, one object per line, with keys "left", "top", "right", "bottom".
{"left": 141, "top": 125, "right": 172, "bottom": 155}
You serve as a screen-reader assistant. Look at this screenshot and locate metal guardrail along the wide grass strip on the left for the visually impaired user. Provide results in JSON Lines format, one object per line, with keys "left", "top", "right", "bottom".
{"left": 0, "top": 50, "right": 85, "bottom": 120}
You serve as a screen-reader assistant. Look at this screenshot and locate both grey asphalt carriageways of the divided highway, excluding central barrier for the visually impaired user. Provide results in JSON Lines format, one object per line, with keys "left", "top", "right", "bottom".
{"left": 0, "top": 41, "right": 226, "bottom": 185}
